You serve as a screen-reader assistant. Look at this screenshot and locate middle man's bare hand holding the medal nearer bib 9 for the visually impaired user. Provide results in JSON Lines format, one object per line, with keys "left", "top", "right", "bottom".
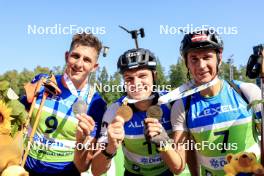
{"left": 107, "top": 116, "right": 125, "bottom": 153}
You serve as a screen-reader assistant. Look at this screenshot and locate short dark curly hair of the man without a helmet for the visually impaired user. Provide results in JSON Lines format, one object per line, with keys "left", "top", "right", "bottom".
{"left": 70, "top": 32, "right": 102, "bottom": 55}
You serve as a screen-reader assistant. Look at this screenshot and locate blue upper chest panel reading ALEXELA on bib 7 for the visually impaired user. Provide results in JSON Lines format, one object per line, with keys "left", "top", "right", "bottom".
{"left": 186, "top": 87, "right": 252, "bottom": 128}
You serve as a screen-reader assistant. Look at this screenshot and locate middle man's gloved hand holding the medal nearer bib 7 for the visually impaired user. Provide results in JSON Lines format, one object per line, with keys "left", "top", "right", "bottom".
{"left": 144, "top": 118, "right": 170, "bottom": 146}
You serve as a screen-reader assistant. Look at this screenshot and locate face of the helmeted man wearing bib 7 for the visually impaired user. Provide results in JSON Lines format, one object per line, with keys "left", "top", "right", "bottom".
{"left": 187, "top": 49, "right": 221, "bottom": 85}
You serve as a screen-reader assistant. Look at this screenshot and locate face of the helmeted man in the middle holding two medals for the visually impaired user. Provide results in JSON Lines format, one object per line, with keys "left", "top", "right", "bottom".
{"left": 123, "top": 68, "right": 153, "bottom": 100}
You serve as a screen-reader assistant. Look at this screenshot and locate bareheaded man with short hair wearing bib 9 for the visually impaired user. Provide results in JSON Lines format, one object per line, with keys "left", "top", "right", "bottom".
{"left": 23, "top": 33, "right": 106, "bottom": 176}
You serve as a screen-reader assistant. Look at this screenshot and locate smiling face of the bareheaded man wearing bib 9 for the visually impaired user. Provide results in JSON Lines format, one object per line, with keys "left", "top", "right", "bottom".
{"left": 65, "top": 45, "right": 98, "bottom": 84}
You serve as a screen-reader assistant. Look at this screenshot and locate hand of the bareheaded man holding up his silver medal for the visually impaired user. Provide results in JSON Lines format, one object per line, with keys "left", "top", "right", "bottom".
{"left": 76, "top": 114, "right": 95, "bottom": 143}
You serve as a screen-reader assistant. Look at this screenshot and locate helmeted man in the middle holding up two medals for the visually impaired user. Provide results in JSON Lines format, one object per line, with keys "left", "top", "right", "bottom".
{"left": 89, "top": 48, "right": 185, "bottom": 176}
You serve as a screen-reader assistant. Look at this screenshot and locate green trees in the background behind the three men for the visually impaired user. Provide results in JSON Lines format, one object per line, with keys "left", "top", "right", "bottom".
{"left": 0, "top": 58, "right": 255, "bottom": 103}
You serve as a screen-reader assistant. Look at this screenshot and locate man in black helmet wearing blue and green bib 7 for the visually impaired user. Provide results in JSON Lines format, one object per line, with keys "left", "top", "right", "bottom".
{"left": 171, "top": 30, "right": 261, "bottom": 176}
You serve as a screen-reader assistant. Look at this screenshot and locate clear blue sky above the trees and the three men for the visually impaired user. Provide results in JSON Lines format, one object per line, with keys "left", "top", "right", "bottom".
{"left": 0, "top": 0, "right": 264, "bottom": 74}
